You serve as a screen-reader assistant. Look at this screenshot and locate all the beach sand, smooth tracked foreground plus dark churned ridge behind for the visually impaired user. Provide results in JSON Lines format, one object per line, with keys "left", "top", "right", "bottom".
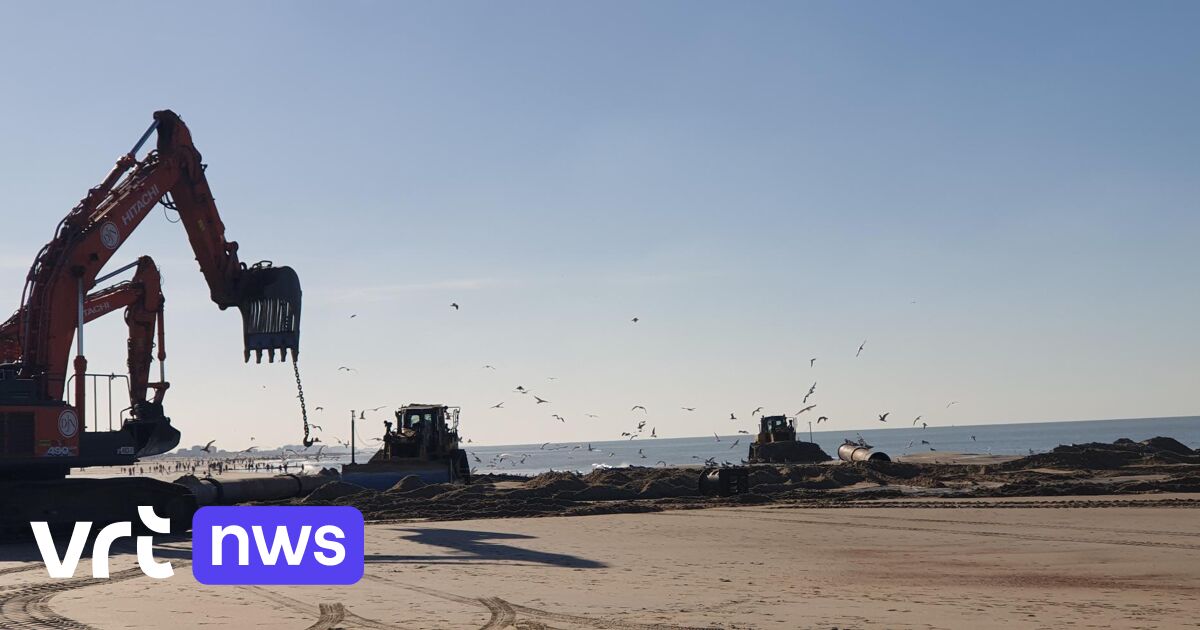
{"left": 0, "top": 438, "right": 1200, "bottom": 630}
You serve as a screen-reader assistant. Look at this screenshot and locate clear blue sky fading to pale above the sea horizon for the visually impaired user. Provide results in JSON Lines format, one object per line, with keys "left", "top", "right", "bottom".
{"left": 0, "top": 1, "right": 1200, "bottom": 449}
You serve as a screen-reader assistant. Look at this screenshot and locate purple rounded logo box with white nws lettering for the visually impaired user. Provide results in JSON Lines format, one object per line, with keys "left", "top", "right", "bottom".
{"left": 192, "top": 505, "right": 366, "bottom": 584}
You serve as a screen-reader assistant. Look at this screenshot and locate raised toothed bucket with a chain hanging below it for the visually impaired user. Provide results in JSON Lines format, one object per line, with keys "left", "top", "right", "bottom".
{"left": 238, "top": 264, "right": 301, "bottom": 362}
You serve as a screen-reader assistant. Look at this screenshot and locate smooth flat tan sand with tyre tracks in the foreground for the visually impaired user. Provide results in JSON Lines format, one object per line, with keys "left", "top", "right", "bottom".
{"left": 0, "top": 494, "right": 1200, "bottom": 630}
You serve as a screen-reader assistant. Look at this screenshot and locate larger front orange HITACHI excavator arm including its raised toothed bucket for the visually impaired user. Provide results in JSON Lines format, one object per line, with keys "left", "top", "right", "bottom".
{"left": 14, "top": 110, "right": 301, "bottom": 410}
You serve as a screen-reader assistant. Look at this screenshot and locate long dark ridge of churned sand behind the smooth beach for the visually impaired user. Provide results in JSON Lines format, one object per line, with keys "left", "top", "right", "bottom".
{"left": 278, "top": 438, "right": 1200, "bottom": 520}
